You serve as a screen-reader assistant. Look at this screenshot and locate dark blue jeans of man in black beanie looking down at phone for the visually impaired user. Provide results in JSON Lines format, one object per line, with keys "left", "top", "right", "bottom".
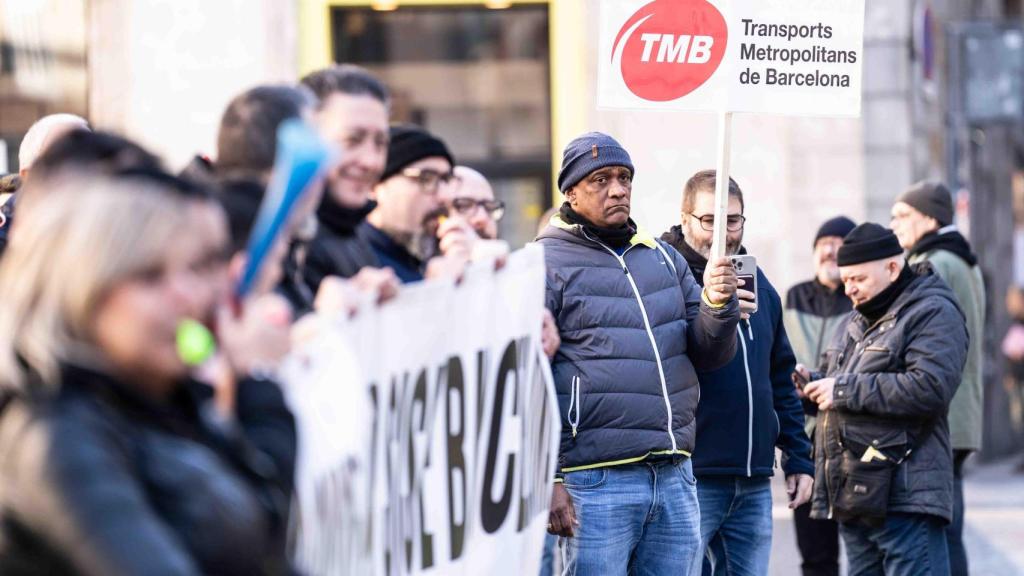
{"left": 839, "top": 513, "right": 949, "bottom": 576}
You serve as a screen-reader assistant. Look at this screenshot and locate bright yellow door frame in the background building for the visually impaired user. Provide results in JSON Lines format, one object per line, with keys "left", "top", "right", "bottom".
{"left": 299, "top": 0, "right": 591, "bottom": 205}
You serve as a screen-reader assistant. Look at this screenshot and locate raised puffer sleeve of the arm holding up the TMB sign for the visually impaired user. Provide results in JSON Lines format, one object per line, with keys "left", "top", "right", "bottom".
{"left": 666, "top": 246, "right": 739, "bottom": 371}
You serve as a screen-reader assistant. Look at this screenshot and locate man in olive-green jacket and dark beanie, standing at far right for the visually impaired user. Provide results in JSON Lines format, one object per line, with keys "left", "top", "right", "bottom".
{"left": 892, "top": 181, "right": 985, "bottom": 576}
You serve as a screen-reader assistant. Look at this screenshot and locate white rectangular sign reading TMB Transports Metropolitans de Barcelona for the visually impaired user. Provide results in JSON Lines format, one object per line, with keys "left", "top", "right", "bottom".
{"left": 598, "top": 0, "right": 864, "bottom": 116}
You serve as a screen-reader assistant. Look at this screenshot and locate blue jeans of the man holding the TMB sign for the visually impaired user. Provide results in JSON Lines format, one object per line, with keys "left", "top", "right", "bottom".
{"left": 559, "top": 459, "right": 700, "bottom": 576}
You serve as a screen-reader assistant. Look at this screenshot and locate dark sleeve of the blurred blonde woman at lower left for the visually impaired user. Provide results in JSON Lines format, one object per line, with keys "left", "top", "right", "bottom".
{"left": 4, "top": 407, "right": 200, "bottom": 576}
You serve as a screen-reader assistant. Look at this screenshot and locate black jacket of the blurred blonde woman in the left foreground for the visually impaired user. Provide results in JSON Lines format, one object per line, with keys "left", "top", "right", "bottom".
{"left": 0, "top": 367, "right": 296, "bottom": 576}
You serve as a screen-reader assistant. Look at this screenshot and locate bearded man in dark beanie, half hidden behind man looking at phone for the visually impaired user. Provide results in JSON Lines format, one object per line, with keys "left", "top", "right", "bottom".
{"left": 782, "top": 216, "right": 857, "bottom": 576}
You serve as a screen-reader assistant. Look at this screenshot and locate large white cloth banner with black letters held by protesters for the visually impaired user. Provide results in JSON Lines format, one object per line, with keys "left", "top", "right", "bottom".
{"left": 283, "top": 246, "right": 560, "bottom": 576}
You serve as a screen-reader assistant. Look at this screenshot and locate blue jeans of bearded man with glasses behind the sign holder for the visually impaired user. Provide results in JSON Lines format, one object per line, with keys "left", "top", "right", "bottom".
{"left": 697, "top": 477, "right": 771, "bottom": 576}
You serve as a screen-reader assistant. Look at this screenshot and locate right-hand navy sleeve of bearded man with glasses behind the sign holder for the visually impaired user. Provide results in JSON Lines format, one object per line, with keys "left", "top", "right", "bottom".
{"left": 760, "top": 277, "right": 814, "bottom": 476}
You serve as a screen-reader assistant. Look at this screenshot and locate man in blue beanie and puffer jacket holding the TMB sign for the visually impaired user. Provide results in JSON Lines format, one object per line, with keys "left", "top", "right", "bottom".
{"left": 539, "top": 132, "right": 739, "bottom": 575}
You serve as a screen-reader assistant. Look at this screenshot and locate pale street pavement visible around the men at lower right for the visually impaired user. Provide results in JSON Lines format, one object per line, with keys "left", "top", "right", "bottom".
{"left": 771, "top": 457, "right": 1024, "bottom": 576}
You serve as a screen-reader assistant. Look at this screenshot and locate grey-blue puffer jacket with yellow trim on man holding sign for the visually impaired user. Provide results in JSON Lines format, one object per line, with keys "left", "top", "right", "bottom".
{"left": 539, "top": 216, "right": 739, "bottom": 472}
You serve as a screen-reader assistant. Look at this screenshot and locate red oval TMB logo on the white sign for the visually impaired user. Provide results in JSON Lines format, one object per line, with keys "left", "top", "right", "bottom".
{"left": 611, "top": 0, "right": 728, "bottom": 101}
